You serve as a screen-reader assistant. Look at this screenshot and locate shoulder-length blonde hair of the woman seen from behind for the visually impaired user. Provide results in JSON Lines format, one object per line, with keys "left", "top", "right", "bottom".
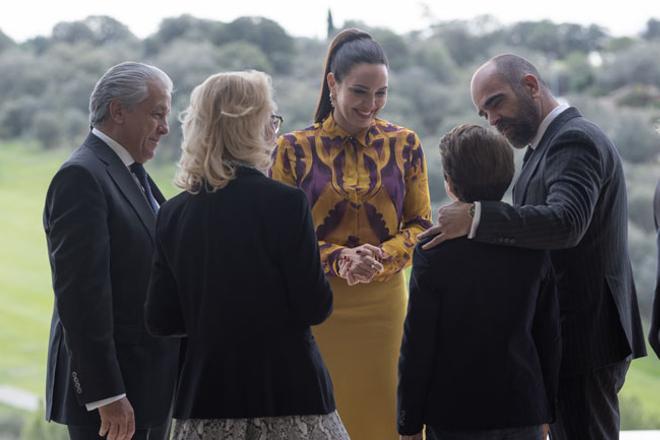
{"left": 174, "top": 70, "right": 275, "bottom": 194}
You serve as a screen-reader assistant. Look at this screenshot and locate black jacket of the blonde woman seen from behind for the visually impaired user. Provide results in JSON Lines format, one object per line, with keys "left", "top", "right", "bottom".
{"left": 146, "top": 167, "right": 335, "bottom": 419}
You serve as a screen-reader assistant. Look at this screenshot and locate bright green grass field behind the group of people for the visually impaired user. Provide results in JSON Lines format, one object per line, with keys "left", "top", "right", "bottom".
{"left": 0, "top": 139, "right": 660, "bottom": 429}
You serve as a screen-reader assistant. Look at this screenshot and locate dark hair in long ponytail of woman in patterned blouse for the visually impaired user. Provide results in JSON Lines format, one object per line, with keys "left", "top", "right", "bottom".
{"left": 314, "top": 28, "right": 389, "bottom": 122}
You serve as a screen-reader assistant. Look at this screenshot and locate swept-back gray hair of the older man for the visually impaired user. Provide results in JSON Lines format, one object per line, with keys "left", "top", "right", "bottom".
{"left": 89, "top": 61, "right": 174, "bottom": 127}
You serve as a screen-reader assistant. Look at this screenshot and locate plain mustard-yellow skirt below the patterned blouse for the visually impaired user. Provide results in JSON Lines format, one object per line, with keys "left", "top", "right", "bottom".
{"left": 313, "top": 272, "right": 408, "bottom": 440}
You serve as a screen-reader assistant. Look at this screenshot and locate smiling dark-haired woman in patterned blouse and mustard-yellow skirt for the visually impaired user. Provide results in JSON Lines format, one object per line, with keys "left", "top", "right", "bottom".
{"left": 271, "top": 29, "right": 431, "bottom": 440}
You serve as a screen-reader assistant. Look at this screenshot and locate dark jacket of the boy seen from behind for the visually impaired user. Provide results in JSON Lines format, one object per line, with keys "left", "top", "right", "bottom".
{"left": 398, "top": 238, "right": 561, "bottom": 435}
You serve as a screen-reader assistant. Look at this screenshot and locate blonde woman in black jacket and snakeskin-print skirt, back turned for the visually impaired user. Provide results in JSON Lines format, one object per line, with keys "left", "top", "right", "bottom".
{"left": 146, "top": 71, "right": 348, "bottom": 440}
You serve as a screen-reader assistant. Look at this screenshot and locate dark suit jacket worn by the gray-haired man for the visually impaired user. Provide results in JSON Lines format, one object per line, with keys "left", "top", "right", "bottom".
{"left": 44, "top": 134, "right": 179, "bottom": 428}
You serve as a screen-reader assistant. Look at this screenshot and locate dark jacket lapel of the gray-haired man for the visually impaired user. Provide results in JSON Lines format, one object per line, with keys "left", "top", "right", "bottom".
{"left": 85, "top": 134, "right": 157, "bottom": 240}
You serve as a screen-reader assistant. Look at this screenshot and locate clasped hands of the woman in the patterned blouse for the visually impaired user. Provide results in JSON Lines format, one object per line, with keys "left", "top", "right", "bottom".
{"left": 339, "top": 244, "right": 389, "bottom": 286}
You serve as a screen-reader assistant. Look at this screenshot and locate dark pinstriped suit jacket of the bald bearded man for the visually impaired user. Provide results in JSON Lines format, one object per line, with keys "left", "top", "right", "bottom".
{"left": 476, "top": 107, "right": 646, "bottom": 375}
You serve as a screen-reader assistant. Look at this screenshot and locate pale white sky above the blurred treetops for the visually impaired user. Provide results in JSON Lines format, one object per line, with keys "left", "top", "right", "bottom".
{"left": 0, "top": 0, "right": 660, "bottom": 41}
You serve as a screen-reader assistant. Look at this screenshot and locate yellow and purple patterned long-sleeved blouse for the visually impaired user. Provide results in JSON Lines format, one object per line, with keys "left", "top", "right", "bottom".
{"left": 271, "top": 115, "right": 431, "bottom": 281}
